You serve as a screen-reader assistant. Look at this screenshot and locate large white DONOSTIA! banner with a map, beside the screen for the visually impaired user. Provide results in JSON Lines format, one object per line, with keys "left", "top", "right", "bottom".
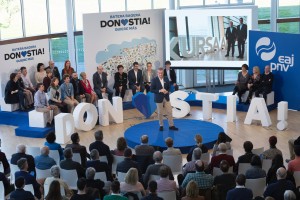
{"left": 83, "top": 9, "right": 164, "bottom": 86}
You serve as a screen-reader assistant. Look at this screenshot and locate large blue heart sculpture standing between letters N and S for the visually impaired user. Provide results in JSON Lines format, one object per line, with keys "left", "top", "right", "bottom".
{"left": 132, "top": 92, "right": 156, "bottom": 119}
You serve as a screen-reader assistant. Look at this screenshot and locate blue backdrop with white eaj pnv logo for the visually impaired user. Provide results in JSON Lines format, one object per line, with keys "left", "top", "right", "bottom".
{"left": 249, "top": 31, "right": 300, "bottom": 110}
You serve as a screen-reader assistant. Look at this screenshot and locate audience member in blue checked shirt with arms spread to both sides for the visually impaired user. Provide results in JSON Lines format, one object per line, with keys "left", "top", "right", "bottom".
{"left": 181, "top": 160, "right": 214, "bottom": 189}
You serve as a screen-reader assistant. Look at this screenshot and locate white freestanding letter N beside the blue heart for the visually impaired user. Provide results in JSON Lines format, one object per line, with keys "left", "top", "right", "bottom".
{"left": 98, "top": 97, "right": 123, "bottom": 126}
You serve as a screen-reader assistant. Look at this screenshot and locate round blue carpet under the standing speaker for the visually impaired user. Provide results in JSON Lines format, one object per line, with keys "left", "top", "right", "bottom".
{"left": 124, "top": 119, "right": 224, "bottom": 153}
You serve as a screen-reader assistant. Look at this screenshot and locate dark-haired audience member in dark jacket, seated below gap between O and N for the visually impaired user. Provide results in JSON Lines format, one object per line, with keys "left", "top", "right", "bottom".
{"left": 89, "top": 130, "right": 113, "bottom": 168}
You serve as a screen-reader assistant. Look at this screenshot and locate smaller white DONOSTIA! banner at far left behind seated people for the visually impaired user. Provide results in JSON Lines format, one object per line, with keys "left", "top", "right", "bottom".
{"left": 0, "top": 39, "right": 50, "bottom": 97}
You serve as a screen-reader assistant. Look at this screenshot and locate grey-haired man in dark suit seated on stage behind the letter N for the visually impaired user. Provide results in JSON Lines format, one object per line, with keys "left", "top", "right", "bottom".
{"left": 93, "top": 65, "right": 113, "bottom": 102}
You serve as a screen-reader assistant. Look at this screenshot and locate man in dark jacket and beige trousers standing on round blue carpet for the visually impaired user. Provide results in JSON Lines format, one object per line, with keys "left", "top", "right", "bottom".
{"left": 151, "top": 68, "right": 178, "bottom": 131}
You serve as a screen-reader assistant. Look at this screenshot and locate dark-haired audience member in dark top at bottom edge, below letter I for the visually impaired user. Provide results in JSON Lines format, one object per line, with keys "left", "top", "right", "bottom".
{"left": 226, "top": 174, "right": 253, "bottom": 200}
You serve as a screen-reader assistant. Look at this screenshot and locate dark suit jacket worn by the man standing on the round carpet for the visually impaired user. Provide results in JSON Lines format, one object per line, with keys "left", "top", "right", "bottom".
{"left": 150, "top": 76, "right": 170, "bottom": 103}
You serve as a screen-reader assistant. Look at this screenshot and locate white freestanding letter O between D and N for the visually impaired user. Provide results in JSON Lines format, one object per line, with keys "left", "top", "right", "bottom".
{"left": 73, "top": 103, "right": 98, "bottom": 131}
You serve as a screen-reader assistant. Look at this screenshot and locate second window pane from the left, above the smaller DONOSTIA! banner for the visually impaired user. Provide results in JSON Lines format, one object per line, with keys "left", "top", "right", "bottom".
{"left": 23, "top": 0, "right": 48, "bottom": 37}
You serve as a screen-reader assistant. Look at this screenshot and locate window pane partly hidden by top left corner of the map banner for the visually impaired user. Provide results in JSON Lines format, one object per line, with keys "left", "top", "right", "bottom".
{"left": 74, "top": 0, "right": 99, "bottom": 31}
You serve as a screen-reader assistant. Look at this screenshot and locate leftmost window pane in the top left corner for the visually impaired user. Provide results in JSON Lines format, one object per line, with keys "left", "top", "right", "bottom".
{"left": 0, "top": 0, "right": 23, "bottom": 40}
